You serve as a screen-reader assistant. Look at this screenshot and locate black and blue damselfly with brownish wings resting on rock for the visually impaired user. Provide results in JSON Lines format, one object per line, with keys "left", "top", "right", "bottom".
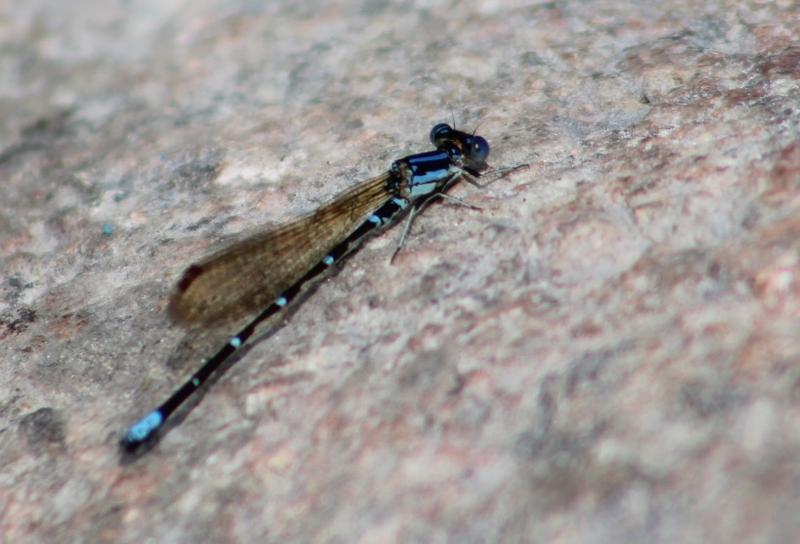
{"left": 122, "top": 123, "right": 512, "bottom": 452}
